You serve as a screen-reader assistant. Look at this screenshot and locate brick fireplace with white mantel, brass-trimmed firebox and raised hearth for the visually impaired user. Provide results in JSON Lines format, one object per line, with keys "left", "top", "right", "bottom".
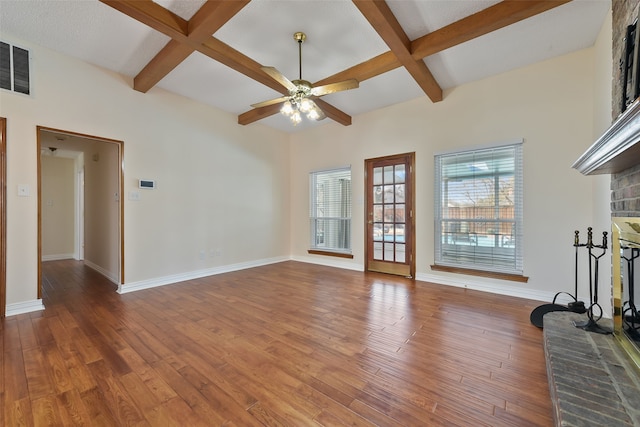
{"left": 544, "top": 0, "right": 640, "bottom": 426}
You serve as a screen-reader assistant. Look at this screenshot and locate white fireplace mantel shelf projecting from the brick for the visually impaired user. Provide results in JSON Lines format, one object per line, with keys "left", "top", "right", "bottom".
{"left": 572, "top": 99, "right": 640, "bottom": 175}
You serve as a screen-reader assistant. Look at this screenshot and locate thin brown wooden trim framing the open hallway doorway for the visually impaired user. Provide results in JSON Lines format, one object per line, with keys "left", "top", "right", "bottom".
{"left": 36, "top": 126, "right": 124, "bottom": 299}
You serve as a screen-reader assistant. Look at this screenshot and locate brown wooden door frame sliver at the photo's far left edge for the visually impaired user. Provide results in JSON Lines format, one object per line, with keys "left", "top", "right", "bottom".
{"left": 0, "top": 117, "right": 7, "bottom": 319}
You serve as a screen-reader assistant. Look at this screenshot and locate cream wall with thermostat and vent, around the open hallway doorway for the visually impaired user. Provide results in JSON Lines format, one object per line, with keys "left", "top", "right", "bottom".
{"left": 0, "top": 33, "right": 290, "bottom": 306}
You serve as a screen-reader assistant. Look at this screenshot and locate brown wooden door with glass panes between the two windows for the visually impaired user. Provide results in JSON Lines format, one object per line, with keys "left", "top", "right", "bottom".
{"left": 365, "top": 153, "right": 415, "bottom": 277}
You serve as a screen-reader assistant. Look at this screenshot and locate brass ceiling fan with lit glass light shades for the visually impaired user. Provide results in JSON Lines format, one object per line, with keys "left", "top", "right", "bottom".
{"left": 251, "top": 32, "right": 359, "bottom": 126}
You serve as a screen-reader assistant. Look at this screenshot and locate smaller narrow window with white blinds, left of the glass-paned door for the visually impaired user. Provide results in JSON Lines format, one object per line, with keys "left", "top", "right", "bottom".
{"left": 309, "top": 167, "right": 351, "bottom": 253}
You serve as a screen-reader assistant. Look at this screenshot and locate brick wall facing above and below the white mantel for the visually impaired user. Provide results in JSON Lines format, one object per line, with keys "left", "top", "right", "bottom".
{"left": 611, "top": 0, "right": 640, "bottom": 217}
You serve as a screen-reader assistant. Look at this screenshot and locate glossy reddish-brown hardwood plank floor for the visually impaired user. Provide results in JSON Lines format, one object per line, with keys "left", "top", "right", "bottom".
{"left": 0, "top": 261, "right": 553, "bottom": 426}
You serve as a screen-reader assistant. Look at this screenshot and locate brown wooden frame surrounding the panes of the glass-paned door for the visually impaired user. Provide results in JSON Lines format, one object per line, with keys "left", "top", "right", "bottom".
{"left": 364, "top": 152, "right": 416, "bottom": 279}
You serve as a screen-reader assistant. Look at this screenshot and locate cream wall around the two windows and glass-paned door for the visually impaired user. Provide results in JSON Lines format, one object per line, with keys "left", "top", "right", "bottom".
{"left": 291, "top": 48, "right": 595, "bottom": 300}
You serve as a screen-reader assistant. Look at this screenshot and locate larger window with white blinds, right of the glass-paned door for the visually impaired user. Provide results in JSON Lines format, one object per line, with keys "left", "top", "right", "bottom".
{"left": 435, "top": 143, "right": 523, "bottom": 274}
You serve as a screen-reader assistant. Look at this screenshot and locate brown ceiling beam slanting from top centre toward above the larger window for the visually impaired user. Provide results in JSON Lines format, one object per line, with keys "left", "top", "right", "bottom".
{"left": 353, "top": 0, "right": 442, "bottom": 102}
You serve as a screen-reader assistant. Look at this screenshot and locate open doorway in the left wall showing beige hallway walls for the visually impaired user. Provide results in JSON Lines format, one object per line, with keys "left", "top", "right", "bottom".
{"left": 37, "top": 126, "right": 124, "bottom": 298}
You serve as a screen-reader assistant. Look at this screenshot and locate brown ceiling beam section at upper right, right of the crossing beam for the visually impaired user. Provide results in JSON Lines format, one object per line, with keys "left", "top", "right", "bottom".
{"left": 411, "top": 0, "right": 571, "bottom": 60}
